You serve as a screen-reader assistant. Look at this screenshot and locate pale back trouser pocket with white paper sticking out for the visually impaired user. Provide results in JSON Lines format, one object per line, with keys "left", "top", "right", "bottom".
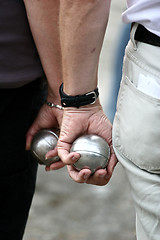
{"left": 113, "top": 76, "right": 160, "bottom": 173}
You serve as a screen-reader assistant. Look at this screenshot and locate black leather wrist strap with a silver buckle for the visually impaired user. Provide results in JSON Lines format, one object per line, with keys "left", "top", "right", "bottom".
{"left": 59, "top": 83, "right": 99, "bottom": 108}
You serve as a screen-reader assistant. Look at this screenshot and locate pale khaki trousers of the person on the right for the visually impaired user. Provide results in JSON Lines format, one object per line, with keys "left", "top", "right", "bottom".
{"left": 113, "top": 25, "right": 160, "bottom": 240}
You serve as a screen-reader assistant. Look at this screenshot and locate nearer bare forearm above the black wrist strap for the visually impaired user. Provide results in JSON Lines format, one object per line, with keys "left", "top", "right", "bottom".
{"left": 60, "top": 0, "right": 110, "bottom": 95}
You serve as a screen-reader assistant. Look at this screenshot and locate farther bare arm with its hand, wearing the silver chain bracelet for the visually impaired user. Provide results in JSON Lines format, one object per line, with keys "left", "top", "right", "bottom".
{"left": 24, "top": 0, "right": 63, "bottom": 169}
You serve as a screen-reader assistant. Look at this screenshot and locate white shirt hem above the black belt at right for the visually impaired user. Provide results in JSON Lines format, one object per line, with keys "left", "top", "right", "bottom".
{"left": 122, "top": 0, "right": 160, "bottom": 36}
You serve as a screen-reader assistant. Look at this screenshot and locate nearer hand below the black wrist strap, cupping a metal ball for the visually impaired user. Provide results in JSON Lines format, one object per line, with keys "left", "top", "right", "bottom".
{"left": 57, "top": 101, "right": 117, "bottom": 185}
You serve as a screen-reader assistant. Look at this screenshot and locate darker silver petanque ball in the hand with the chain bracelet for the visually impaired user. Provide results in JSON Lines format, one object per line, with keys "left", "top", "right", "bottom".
{"left": 31, "top": 129, "right": 59, "bottom": 166}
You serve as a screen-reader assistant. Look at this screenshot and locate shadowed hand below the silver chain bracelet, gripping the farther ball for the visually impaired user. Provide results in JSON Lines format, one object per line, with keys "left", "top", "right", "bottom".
{"left": 26, "top": 101, "right": 64, "bottom": 171}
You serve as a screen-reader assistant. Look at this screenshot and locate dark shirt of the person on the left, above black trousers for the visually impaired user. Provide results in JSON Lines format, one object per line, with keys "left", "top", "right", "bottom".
{"left": 0, "top": 0, "right": 43, "bottom": 88}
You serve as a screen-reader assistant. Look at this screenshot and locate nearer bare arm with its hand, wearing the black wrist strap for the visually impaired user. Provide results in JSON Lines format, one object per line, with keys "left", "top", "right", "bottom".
{"left": 58, "top": 0, "right": 117, "bottom": 185}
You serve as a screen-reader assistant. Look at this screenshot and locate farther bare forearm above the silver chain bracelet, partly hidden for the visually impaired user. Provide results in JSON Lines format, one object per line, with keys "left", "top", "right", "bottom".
{"left": 24, "top": 0, "right": 62, "bottom": 103}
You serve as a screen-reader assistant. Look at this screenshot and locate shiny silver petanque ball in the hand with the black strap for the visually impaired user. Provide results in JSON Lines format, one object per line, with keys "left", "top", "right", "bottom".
{"left": 70, "top": 135, "right": 110, "bottom": 173}
